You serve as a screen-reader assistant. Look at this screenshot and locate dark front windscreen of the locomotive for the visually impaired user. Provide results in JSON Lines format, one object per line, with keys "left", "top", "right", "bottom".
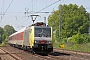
{"left": 35, "top": 28, "right": 51, "bottom": 37}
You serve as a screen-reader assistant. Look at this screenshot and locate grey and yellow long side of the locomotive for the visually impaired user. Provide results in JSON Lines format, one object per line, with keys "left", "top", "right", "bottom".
{"left": 24, "top": 26, "right": 34, "bottom": 48}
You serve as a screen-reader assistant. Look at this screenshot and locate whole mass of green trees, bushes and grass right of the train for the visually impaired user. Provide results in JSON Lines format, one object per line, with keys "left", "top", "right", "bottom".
{"left": 48, "top": 4, "right": 90, "bottom": 52}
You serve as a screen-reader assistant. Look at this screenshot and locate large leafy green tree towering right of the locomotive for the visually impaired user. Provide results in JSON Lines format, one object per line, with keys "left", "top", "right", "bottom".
{"left": 48, "top": 4, "right": 89, "bottom": 40}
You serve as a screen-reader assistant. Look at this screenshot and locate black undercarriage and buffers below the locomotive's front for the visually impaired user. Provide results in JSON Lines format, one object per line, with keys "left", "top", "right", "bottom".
{"left": 33, "top": 44, "right": 53, "bottom": 53}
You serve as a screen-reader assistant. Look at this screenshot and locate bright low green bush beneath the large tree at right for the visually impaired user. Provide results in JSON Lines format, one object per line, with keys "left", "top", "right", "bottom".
{"left": 68, "top": 33, "right": 90, "bottom": 44}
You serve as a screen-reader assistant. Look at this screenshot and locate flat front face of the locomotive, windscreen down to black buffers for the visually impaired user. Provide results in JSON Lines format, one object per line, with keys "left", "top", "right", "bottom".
{"left": 33, "top": 26, "right": 53, "bottom": 53}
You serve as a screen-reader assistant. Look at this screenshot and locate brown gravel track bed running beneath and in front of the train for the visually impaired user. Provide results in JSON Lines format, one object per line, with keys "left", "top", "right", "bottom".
{"left": 0, "top": 45, "right": 90, "bottom": 60}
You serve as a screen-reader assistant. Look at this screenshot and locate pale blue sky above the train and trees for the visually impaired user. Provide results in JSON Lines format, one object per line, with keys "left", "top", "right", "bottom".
{"left": 0, "top": 0, "right": 90, "bottom": 31}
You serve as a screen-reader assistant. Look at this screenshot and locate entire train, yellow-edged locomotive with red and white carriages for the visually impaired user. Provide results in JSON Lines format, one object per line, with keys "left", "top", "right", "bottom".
{"left": 8, "top": 22, "right": 53, "bottom": 54}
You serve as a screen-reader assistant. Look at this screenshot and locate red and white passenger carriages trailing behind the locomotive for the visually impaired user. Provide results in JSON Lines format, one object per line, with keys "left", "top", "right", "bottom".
{"left": 8, "top": 27, "right": 26, "bottom": 46}
